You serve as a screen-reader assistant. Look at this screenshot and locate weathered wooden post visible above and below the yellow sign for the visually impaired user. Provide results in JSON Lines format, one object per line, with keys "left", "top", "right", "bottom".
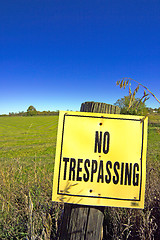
{"left": 59, "top": 102, "right": 120, "bottom": 240}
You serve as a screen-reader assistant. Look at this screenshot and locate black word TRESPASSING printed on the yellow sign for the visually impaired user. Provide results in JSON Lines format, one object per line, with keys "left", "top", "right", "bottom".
{"left": 63, "top": 157, "right": 140, "bottom": 186}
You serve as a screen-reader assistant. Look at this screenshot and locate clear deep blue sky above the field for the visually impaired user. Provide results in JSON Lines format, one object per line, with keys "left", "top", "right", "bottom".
{"left": 0, "top": 0, "right": 160, "bottom": 114}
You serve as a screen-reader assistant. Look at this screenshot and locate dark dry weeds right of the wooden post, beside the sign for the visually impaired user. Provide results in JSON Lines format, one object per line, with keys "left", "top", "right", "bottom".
{"left": 104, "top": 158, "right": 160, "bottom": 240}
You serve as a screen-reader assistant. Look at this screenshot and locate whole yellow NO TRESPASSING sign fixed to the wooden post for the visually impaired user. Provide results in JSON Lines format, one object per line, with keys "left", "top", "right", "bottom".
{"left": 52, "top": 111, "right": 148, "bottom": 208}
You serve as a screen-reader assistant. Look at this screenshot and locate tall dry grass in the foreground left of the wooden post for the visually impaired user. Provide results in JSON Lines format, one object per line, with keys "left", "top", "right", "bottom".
{"left": 0, "top": 158, "right": 62, "bottom": 240}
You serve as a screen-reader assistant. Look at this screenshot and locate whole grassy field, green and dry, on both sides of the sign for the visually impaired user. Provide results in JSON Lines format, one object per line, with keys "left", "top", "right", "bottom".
{"left": 0, "top": 116, "right": 160, "bottom": 240}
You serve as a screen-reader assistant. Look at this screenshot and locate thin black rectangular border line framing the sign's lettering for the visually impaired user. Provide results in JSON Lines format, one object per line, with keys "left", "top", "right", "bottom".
{"left": 57, "top": 113, "right": 144, "bottom": 202}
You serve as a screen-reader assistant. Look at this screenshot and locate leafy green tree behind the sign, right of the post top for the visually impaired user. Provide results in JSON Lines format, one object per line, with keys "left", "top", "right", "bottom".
{"left": 114, "top": 96, "right": 147, "bottom": 115}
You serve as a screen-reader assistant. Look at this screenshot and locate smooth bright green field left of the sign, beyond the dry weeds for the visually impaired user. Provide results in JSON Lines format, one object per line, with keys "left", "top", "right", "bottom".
{"left": 0, "top": 116, "right": 58, "bottom": 158}
